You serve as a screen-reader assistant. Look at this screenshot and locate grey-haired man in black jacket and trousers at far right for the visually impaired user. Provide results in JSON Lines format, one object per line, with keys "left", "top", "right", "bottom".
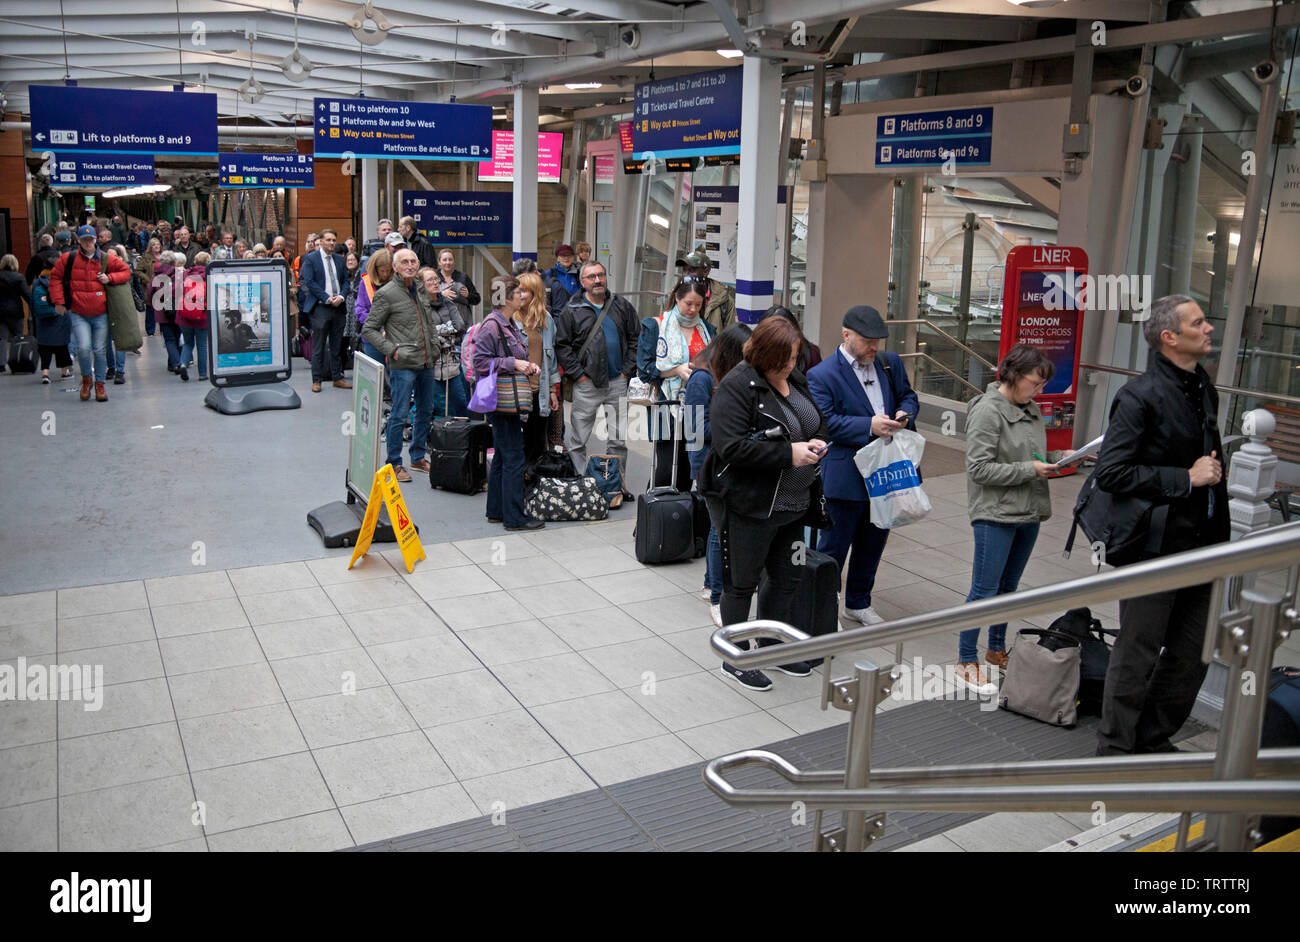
{"left": 1096, "top": 295, "right": 1229, "bottom": 755}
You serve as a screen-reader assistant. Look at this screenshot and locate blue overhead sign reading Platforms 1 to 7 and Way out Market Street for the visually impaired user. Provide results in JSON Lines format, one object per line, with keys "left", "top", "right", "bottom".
{"left": 632, "top": 68, "right": 742, "bottom": 160}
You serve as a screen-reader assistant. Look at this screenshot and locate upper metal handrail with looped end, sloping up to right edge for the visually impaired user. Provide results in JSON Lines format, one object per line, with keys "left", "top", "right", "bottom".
{"left": 710, "top": 521, "right": 1300, "bottom": 670}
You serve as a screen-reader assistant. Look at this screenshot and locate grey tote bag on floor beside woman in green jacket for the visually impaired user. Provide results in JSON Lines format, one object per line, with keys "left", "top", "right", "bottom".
{"left": 997, "top": 628, "right": 1079, "bottom": 726}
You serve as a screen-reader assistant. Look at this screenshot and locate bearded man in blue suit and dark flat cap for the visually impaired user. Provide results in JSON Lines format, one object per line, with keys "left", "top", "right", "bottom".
{"left": 807, "top": 304, "right": 919, "bottom": 625}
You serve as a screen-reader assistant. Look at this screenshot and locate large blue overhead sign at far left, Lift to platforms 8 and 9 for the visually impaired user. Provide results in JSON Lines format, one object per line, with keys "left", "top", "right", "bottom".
{"left": 29, "top": 84, "right": 217, "bottom": 155}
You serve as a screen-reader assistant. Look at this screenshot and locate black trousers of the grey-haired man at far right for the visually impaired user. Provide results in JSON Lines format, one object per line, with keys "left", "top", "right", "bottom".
{"left": 1097, "top": 583, "right": 1210, "bottom": 755}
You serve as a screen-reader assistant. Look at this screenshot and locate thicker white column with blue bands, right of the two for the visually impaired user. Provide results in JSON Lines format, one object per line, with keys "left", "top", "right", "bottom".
{"left": 736, "top": 56, "right": 781, "bottom": 324}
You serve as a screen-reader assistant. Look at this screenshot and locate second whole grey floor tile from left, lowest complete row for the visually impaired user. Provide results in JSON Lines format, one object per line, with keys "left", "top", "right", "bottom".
{"left": 194, "top": 752, "right": 334, "bottom": 838}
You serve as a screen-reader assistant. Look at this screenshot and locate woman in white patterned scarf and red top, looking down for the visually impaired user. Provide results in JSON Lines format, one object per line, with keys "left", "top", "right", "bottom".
{"left": 642, "top": 281, "right": 714, "bottom": 491}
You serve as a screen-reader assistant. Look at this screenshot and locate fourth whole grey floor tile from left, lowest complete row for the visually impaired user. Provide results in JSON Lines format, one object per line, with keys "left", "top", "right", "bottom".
{"left": 425, "top": 709, "right": 564, "bottom": 781}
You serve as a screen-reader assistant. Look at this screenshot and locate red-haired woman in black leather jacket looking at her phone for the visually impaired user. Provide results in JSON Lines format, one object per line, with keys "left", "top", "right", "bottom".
{"left": 699, "top": 317, "right": 828, "bottom": 690}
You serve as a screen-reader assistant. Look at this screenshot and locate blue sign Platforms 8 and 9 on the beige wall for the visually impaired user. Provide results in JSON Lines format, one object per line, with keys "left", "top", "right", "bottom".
{"left": 876, "top": 108, "right": 993, "bottom": 166}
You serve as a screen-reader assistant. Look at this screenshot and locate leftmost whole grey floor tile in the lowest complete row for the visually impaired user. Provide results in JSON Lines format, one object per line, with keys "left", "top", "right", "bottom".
{"left": 59, "top": 776, "right": 202, "bottom": 852}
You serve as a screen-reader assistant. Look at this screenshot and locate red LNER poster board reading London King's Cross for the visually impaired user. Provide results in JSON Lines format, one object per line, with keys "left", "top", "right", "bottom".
{"left": 997, "top": 246, "right": 1088, "bottom": 451}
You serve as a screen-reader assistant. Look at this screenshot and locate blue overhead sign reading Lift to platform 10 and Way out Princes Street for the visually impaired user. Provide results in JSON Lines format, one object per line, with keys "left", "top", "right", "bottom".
{"left": 312, "top": 99, "right": 491, "bottom": 160}
